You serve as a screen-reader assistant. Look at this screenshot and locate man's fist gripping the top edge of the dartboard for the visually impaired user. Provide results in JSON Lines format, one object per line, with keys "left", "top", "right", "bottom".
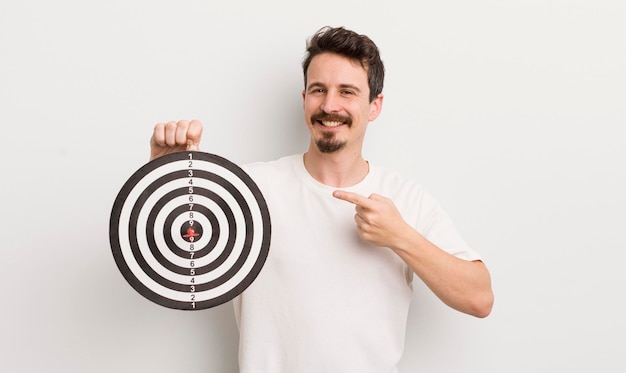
{"left": 150, "top": 120, "right": 202, "bottom": 160}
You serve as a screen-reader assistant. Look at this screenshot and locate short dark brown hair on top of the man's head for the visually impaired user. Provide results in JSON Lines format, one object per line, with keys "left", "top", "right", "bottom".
{"left": 302, "top": 26, "right": 385, "bottom": 102}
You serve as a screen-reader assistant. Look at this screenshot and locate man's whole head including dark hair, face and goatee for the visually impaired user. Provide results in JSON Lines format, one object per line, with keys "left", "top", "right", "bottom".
{"left": 302, "top": 27, "right": 384, "bottom": 154}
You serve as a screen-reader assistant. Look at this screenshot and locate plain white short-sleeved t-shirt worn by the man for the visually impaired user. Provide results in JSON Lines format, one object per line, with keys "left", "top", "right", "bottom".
{"left": 234, "top": 154, "right": 480, "bottom": 373}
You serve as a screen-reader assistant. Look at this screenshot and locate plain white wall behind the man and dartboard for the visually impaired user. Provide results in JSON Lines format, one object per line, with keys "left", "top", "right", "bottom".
{"left": 0, "top": 0, "right": 626, "bottom": 373}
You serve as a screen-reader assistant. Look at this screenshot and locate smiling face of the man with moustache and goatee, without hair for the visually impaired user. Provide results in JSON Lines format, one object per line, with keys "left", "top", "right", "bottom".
{"left": 302, "top": 53, "right": 382, "bottom": 154}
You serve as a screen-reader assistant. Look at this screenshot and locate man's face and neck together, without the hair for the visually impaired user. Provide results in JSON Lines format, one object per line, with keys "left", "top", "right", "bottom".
{"left": 302, "top": 49, "right": 383, "bottom": 187}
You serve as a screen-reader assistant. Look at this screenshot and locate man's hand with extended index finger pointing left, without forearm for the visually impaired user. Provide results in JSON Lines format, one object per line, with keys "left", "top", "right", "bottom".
{"left": 333, "top": 190, "right": 413, "bottom": 249}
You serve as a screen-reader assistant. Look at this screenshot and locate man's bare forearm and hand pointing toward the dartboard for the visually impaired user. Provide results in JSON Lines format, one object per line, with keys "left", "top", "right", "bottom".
{"left": 333, "top": 191, "right": 493, "bottom": 317}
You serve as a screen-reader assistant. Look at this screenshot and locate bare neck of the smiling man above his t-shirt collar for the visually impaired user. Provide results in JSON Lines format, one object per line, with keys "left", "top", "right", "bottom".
{"left": 304, "top": 149, "right": 369, "bottom": 188}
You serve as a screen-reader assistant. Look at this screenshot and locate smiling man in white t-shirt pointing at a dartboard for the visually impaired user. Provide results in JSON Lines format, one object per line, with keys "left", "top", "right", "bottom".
{"left": 151, "top": 28, "right": 493, "bottom": 373}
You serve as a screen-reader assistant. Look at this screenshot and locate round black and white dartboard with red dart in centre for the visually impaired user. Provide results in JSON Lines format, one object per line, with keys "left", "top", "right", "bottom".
{"left": 109, "top": 151, "right": 271, "bottom": 310}
